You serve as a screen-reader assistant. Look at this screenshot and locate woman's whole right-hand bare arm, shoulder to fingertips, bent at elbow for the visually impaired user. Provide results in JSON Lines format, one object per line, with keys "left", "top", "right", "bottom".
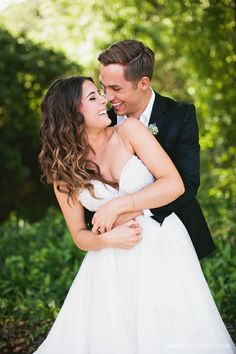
{"left": 92, "top": 118, "right": 184, "bottom": 231}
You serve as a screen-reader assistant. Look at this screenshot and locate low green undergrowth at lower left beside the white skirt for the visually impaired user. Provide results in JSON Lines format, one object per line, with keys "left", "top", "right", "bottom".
{"left": 0, "top": 210, "right": 85, "bottom": 353}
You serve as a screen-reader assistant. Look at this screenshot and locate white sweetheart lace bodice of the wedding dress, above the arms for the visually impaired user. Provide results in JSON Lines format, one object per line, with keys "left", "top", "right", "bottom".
{"left": 78, "top": 155, "right": 154, "bottom": 211}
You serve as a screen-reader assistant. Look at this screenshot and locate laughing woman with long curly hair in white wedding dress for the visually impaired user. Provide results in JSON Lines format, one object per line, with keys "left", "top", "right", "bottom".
{"left": 35, "top": 77, "right": 236, "bottom": 354}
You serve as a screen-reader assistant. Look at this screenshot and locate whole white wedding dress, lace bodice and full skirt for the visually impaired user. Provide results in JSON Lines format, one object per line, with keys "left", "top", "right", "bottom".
{"left": 35, "top": 156, "right": 236, "bottom": 354}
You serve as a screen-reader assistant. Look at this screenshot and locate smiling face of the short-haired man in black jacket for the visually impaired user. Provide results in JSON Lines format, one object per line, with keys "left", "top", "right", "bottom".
{"left": 100, "top": 64, "right": 143, "bottom": 118}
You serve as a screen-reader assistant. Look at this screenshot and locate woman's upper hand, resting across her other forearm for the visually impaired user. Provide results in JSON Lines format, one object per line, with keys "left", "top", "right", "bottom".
{"left": 92, "top": 197, "right": 124, "bottom": 233}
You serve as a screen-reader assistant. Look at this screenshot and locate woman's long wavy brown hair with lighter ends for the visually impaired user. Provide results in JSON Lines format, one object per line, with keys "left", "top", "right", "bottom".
{"left": 39, "top": 76, "right": 117, "bottom": 199}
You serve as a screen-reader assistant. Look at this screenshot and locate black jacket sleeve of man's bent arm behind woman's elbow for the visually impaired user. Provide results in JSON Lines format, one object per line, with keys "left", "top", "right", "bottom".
{"left": 151, "top": 105, "right": 200, "bottom": 217}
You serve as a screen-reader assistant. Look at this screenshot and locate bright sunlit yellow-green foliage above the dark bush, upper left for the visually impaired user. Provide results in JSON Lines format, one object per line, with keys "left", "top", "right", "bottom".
{"left": 0, "top": 0, "right": 110, "bottom": 71}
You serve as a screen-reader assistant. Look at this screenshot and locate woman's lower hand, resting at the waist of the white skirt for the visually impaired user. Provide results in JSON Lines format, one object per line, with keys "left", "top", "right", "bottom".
{"left": 103, "top": 220, "right": 142, "bottom": 250}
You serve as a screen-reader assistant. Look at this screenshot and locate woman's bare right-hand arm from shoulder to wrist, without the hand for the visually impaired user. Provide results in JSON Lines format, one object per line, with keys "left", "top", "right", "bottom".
{"left": 120, "top": 118, "right": 184, "bottom": 212}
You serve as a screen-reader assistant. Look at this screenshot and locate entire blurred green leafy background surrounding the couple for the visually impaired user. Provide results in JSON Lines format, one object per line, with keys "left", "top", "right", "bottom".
{"left": 0, "top": 0, "right": 236, "bottom": 353}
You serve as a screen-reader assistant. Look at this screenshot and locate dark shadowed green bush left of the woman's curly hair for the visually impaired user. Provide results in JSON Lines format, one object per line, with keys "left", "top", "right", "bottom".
{"left": 0, "top": 30, "right": 80, "bottom": 220}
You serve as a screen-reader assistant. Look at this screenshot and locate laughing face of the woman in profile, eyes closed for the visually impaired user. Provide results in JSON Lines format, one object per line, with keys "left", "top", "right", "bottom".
{"left": 79, "top": 81, "right": 111, "bottom": 129}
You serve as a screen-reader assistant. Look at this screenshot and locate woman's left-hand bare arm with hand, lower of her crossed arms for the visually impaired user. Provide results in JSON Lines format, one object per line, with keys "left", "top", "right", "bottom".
{"left": 54, "top": 184, "right": 141, "bottom": 251}
